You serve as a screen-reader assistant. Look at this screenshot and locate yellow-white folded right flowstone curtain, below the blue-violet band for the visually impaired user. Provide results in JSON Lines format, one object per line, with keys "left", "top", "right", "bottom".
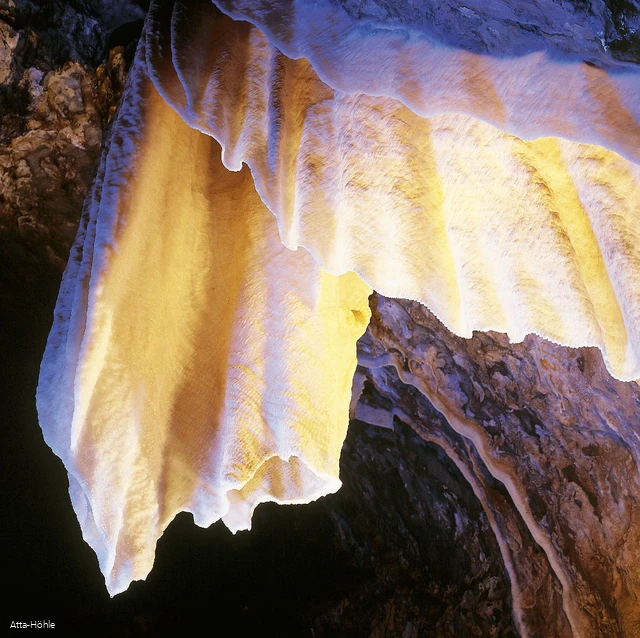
{"left": 146, "top": 0, "right": 640, "bottom": 380}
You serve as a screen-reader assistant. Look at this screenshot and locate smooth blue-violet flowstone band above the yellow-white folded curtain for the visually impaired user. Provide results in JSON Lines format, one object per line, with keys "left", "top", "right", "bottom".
{"left": 214, "top": 0, "right": 640, "bottom": 160}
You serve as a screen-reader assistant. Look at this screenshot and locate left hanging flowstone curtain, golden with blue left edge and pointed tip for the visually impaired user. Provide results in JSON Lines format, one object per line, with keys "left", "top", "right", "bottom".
{"left": 38, "top": 35, "right": 371, "bottom": 594}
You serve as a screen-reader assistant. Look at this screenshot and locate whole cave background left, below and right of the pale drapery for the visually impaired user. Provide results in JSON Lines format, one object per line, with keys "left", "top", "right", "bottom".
{"left": 0, "top": 0, "right": 640, "bottom": 637}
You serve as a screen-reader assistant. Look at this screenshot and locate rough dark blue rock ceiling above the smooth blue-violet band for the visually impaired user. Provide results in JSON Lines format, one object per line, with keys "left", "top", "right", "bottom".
{"left": 332, "top": 0, "right": 640, "bottom": 62}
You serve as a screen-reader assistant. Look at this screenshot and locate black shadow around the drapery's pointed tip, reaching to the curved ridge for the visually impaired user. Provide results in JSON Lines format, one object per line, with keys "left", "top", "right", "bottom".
{"left": 0, "top": 242, "right": 513, "bottom": 637}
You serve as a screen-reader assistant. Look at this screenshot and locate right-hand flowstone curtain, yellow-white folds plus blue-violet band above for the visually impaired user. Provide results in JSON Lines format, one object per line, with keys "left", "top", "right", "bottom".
{"left": 146, "top": 0, "right": 640, "bottom": 380}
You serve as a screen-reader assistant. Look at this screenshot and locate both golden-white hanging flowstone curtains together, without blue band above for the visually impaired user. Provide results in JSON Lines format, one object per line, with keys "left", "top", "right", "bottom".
{"left": 38, "top": 0, "right": 640, "bottom": 594}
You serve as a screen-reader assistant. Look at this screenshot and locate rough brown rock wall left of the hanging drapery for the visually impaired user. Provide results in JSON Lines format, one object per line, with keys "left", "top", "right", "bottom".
{"left": 0, "top": 0, "right": 141, "bottom": 310}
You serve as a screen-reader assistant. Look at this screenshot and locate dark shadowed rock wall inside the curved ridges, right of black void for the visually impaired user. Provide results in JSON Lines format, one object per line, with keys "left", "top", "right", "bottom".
{"left": 310, "top": 422, "right": 516, "bottom": 638}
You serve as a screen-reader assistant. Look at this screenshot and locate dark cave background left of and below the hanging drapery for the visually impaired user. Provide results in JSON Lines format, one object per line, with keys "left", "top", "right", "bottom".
{"left": 0, "top": 0, "right": 640, "bottom": 638}
